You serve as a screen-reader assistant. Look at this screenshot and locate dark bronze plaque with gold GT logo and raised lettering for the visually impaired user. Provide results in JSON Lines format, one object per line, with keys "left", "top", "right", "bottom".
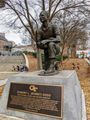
{"left": 7, "top": 83, "right": 62, "bottom": 118}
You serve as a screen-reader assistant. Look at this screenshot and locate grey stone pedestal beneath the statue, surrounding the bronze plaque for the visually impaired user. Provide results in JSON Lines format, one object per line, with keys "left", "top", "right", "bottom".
{"left": 0, "top": 70, "right": 82, "bottom": 120}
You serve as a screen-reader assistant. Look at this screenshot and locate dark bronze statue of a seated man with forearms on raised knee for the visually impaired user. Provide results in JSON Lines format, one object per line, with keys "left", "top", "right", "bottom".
{"left": 36, "top": 11, "right": 60, "bottom": 75}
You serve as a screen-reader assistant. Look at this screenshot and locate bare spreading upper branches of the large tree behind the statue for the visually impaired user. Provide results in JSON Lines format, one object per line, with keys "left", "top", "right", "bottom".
{"left": 1, "top": 0, "right": 89, "bottom": 44}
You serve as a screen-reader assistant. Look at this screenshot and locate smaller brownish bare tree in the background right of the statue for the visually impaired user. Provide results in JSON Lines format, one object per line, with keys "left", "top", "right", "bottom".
{"left": 56, "top": 11, "right": 87, "bottom": 57}
